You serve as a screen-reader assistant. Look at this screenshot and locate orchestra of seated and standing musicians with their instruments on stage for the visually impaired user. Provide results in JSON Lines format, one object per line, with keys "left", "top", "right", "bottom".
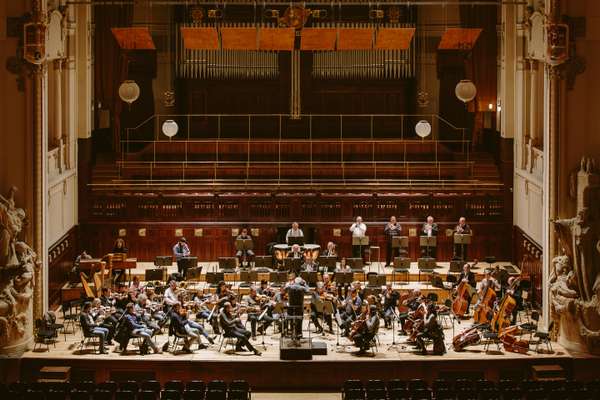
{"left": 64, "top": 216, "right": 523, "bottom": 355}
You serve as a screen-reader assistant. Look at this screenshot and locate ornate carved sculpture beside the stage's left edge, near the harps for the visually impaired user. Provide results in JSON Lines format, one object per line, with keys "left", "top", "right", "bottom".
{"left": 0, "top": 187, "right": 38, "bottom": 354}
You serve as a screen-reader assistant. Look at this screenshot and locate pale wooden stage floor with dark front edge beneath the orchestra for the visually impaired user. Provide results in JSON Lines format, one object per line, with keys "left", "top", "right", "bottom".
{"left": 21, "top": 312, "right": 573, "bottom": 391}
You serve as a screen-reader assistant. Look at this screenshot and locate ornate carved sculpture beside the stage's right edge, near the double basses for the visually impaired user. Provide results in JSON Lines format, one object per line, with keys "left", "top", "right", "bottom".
{"left": 550, "top": 158, "right": 600, "bottom": 353}
